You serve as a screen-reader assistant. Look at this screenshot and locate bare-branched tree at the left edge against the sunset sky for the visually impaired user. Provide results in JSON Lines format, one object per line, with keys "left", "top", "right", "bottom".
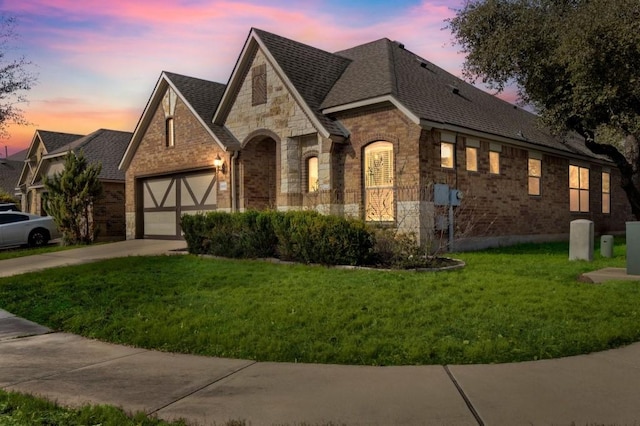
{"left": 0, "top": 15, "right": 36, "bottom": 136}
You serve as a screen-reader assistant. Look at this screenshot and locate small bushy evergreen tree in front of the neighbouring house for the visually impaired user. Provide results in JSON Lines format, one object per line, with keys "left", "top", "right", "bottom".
{"left": 44, "top": 152, "right": 103, "bottom": 244}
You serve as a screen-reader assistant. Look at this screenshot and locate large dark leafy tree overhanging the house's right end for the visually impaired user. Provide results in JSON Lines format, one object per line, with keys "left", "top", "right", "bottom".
{"left": 448, "top": 0, "right": 640, "bottom": 220}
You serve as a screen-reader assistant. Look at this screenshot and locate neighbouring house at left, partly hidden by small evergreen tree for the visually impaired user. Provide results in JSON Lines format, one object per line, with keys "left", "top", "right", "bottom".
{"left": 18, "top": 129, "right": 132, "bottom": 240}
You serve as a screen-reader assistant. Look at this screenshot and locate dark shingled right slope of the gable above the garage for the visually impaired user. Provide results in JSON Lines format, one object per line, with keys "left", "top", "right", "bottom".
{"left": 164, "top": 71, "right": 239, "bottom": 149}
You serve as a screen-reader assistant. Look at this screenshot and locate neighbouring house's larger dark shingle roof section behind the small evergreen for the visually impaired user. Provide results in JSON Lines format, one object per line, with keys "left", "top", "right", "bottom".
{"left": 49, "top": 129, "right": 132, "bottom": 181}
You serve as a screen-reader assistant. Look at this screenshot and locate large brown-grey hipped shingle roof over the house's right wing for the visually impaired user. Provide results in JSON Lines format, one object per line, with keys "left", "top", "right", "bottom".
{"left": 322, "top": 39, "right": 594, "bottom": 157}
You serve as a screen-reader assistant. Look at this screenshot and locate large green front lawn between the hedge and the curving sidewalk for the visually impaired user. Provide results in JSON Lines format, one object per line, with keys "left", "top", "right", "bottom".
{"left": 0, "top": 241, "right": 640, "bottom": 365}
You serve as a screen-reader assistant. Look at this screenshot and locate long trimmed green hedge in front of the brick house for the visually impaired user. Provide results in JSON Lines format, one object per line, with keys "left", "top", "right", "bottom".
{"left": 181, "top": 211, "right": 375, "bottom": 265}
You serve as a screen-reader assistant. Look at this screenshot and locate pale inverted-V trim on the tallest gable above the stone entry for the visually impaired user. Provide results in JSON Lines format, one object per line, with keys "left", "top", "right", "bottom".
{"left": 213, "top": 28, "right": 331, "bottom": 138}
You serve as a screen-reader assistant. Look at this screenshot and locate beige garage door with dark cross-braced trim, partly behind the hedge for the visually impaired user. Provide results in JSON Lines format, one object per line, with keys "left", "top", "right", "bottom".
{"left": 142, "top": 171, "right": 217, "bottom": 238}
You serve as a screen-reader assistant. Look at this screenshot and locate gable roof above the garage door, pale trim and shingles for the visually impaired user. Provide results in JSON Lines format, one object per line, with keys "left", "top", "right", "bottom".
{"left": 119, "top": 71, "right": 240, "bottom": 170}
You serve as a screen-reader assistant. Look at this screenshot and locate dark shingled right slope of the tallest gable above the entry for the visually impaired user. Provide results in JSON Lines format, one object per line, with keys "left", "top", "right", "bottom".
{"left": 253, "top": 28, "right": 351, "bottom": 135}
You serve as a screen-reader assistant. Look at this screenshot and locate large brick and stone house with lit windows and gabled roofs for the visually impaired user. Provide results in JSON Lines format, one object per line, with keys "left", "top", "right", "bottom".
{"left": 120, "top": 28, "right": 630, "bottom": 248}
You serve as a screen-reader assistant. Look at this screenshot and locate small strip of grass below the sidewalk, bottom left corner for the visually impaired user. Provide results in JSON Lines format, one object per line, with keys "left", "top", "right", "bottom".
{"left": 0, "top": 390, "right": 190, "bottom": 426}
